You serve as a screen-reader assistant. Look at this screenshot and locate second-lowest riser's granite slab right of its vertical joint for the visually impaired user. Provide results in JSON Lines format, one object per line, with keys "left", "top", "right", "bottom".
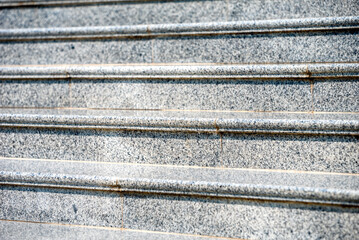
{"left": 221, "top": 134, "right": 359, "bottom": 173}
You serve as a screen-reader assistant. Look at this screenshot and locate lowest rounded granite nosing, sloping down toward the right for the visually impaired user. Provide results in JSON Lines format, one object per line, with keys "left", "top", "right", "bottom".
{"left": 0, "top": 171, "right": 359, "bottom": 204}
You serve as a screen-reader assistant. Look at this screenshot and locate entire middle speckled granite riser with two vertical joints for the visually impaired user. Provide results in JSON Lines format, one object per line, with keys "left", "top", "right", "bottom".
{"left": 0, "top": 78, "right": 359, "bottom": 112}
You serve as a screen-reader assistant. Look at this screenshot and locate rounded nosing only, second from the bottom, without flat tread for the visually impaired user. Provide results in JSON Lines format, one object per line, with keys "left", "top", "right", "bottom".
{"left": 0, "top": 113, "right": 359, "bottom": 135}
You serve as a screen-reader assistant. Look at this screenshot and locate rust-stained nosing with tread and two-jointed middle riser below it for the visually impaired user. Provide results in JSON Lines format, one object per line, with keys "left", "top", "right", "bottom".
{"left": 0, "top": 63, "right": 359, "bottom": 113}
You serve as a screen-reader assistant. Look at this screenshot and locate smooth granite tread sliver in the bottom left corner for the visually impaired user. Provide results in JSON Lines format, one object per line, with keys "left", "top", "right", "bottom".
{"left": 0, "top": 220, "right": 228, "bottom": 240}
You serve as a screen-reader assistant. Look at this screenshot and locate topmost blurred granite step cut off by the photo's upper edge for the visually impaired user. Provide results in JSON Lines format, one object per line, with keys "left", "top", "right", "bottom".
{"left": 0, "top": 0, "right": 359, "bottom": 28}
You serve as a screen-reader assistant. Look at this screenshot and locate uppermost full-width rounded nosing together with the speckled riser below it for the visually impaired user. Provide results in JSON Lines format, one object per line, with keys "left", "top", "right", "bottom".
{"left": 0, "top": 17, "right": 359, "bottom": 65}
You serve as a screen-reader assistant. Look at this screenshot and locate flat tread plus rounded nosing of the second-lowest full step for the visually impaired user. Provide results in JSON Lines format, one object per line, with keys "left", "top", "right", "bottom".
{"left": 0, "top": 108, "right": 359, "bottom": 135}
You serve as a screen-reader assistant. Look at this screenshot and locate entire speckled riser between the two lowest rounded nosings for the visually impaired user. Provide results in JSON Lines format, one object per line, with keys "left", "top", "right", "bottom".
{"left": 0, "top": 128, "right": 359, "bottom": 173}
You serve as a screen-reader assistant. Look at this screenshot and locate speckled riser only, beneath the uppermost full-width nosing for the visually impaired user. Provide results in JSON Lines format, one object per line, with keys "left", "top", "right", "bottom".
{"left": 0, "top": 30, "right": 359, "bottom": 65}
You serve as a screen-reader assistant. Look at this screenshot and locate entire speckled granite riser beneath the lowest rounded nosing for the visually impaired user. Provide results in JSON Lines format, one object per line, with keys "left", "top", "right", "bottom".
{"left": 0, "top": 187, "right": 359, "bottom": 239}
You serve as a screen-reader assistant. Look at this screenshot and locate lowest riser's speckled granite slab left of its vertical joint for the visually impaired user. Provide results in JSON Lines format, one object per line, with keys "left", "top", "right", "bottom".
{"left": 0, "top": 186, "right": 122, "bottom": 227}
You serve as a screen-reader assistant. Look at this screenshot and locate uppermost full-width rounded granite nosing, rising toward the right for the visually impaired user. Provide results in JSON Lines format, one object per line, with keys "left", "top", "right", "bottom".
{"left": 0, "top": 16, "right": 359, "bottom": 41}
